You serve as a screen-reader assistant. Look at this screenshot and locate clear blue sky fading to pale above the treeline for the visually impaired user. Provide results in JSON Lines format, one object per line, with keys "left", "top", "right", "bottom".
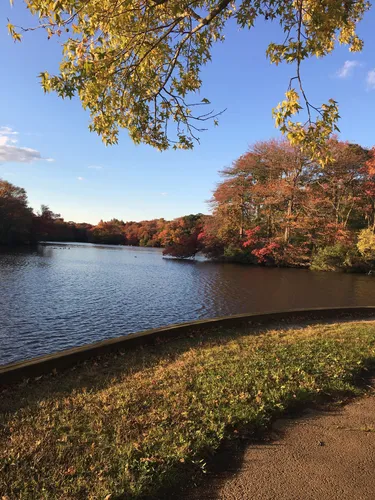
{"left": 0, "top": 4, "right": 375, "bottom": 224}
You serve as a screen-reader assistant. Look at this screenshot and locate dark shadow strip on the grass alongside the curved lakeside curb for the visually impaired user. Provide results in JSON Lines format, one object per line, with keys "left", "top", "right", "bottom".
{"left": 0, "top": 327, "right": 253, "bottom": 413}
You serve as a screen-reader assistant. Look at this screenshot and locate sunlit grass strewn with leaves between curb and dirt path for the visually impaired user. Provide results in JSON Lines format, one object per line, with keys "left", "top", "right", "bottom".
{"left": 0, "top": 322, "right": 375, "bottom": 500}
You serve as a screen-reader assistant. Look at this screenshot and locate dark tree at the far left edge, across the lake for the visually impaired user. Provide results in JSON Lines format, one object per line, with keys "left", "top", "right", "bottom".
{"left": 0, "top": 179, "right": 32, "bottom": 245}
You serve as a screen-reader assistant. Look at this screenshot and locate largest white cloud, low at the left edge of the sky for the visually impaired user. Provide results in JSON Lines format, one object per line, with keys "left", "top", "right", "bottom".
{"left": 0, "top": 127, "right": 54, "bottom": 163}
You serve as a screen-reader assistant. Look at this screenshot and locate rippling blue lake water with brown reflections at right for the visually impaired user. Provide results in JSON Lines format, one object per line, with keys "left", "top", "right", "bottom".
{"left": 0, "top": 243, "right": 375, "bottom": 364}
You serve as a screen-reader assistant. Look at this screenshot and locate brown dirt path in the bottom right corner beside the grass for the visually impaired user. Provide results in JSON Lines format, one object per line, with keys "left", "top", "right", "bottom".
{"left": 179, "top": 392, "right": 375, "bottom": 500}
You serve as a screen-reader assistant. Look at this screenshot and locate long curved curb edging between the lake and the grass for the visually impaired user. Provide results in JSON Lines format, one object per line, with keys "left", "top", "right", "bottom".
{"left": 0, "top": 306, "right": 375, "bottom": 385}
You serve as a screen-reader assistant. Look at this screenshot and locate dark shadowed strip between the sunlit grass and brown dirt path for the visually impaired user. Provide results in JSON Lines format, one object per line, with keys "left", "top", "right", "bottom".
{"left": 162, "top": 372, "right": 375, "bottom": 500}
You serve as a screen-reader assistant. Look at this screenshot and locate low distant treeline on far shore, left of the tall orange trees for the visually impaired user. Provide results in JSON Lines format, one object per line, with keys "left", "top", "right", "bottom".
{"left": 0, "top": 179, "right": 208, "bottom": 257}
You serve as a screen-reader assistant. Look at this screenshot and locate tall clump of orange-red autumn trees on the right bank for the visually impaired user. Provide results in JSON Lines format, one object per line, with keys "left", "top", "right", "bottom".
{"left": 207, "top": 137, "right": 375, "bottom": 267}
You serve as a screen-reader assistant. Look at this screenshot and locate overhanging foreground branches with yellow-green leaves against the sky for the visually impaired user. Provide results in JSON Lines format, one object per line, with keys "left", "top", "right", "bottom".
{"left": 8, "top": 0, "right": 370, "bottom": 164}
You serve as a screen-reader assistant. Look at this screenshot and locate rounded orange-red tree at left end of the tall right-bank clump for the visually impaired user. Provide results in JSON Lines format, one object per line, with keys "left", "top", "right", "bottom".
{"left": 210, "top": 139, "right": 310, "bottom": 260}
